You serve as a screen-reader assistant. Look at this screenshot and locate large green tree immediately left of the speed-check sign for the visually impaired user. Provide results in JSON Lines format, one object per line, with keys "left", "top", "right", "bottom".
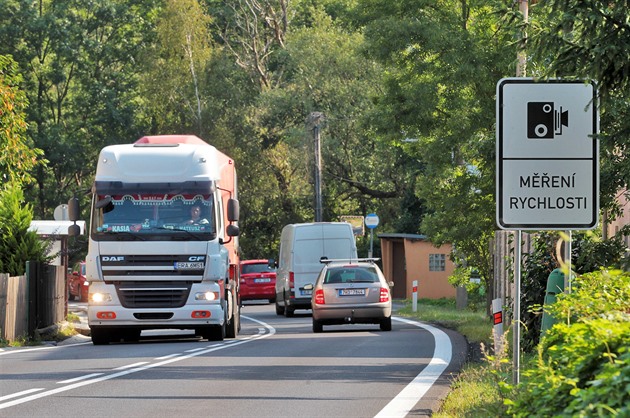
{"left": 356, "top": 0, "right": 516, "bottom": 306}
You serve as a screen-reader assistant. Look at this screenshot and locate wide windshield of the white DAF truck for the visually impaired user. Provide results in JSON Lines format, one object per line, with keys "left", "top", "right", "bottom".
{"left": 91, "top": 192, "right": 216, "bottom": 241}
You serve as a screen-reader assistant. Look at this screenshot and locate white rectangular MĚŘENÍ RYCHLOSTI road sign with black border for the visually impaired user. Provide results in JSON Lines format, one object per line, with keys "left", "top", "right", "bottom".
{"left": 496, "top": 78, "right": 599, "bottom": 230}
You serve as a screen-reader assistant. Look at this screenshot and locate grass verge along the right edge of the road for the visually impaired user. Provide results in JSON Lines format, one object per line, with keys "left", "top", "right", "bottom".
{"left": 398, "top": 299, "right": 512, "bottom": 418}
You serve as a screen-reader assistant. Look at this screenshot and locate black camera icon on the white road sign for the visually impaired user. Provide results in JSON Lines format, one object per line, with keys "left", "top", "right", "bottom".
{"left": 527, "top": 102, "right": 569, "bottom": 139}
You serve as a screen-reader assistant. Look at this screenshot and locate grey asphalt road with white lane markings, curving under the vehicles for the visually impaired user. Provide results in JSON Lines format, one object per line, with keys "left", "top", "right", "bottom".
{"left": 0, "top": 304, "right": 466, "bottom": 417}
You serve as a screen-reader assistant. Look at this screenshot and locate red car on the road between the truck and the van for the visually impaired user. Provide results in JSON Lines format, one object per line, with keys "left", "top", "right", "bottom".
{"left": 241, "top": 260, "right": 276, "bottom": 303}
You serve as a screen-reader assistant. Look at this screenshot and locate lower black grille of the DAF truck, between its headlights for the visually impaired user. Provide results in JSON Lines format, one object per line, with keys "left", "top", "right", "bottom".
{"left": 116, "top": 282, "right": 192, "bottom": 308}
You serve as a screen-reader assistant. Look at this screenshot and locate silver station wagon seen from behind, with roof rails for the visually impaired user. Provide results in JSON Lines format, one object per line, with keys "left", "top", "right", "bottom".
{"left": 304, "top": 259, "right": 392, "bottom": 332}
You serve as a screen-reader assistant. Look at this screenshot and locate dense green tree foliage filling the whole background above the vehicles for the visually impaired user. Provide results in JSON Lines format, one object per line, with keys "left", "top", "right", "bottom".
{"left": 0, "top": 0, "right": 630, "bottom": 290}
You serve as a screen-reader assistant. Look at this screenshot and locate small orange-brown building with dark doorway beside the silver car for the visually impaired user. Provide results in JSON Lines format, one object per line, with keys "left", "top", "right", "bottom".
{"left": 378, "top": 234, "right": 457, "bottom": 299}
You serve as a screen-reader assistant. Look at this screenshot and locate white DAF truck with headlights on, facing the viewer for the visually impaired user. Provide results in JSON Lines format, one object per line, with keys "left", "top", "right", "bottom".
{"left": 86, "top": 135, "right": 240, "bottom": 345}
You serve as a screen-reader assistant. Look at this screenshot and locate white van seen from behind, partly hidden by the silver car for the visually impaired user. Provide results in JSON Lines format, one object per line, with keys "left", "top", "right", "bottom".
{"left": 276, "top": 222, "right": 357, "bottom": 316}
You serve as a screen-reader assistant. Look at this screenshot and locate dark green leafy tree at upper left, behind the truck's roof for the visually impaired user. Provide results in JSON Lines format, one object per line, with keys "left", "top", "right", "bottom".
{"left": 0, "top": 0, "right": 160, "bottom": 217}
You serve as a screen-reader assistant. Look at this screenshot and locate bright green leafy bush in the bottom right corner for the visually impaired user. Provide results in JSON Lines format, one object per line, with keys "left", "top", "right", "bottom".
{"left": 509, "top": 271, "right": 630, "bottom": 417}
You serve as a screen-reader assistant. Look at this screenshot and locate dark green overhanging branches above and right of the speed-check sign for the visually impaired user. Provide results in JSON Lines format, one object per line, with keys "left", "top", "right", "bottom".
{"left": 515, "top": 0, "right": 630, "bottom": 222}
